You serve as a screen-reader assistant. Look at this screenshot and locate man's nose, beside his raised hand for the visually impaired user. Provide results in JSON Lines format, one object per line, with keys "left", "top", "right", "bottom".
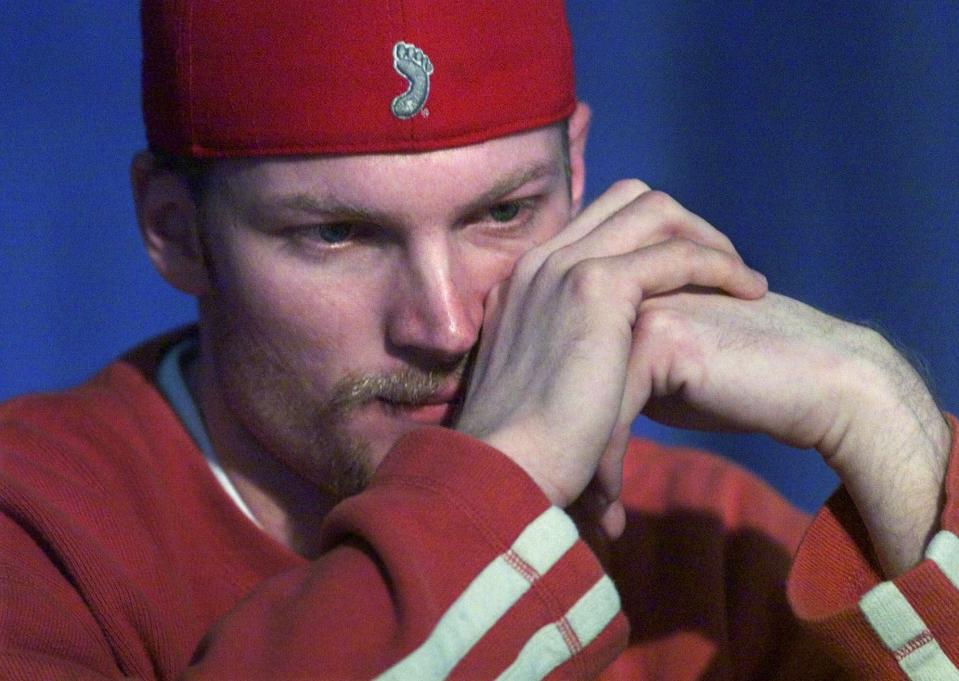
{"left": 387, "top": 236, "right": 484, "bottom": 368}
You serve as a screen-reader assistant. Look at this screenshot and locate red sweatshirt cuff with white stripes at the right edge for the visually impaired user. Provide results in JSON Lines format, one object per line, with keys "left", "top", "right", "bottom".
{"left": 788, "top": 417, "right": 959, "bottom": 681}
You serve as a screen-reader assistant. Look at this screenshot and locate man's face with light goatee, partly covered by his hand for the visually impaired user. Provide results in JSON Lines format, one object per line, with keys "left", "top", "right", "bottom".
{"left": 191, "top": 127, "right": 571, "bottom": 495}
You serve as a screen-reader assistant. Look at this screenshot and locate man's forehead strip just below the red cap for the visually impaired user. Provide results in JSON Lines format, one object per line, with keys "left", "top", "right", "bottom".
{"left": 202, "top": 125, "right": 567, "bottom": 212}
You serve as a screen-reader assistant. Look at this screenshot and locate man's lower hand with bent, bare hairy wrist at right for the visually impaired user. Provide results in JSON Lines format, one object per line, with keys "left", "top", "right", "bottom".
{"left": 626, "top": 292, "right": 950, "bottom": 576}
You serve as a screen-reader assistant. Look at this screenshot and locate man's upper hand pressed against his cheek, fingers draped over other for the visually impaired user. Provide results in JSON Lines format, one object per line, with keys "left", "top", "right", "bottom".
{"left": 457, "top": 181, "right": 766, "bottom": 535}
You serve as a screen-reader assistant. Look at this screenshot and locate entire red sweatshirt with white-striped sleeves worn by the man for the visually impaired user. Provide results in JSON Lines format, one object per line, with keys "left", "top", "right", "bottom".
{"left": 0, "top": 332, "right": 959, "bottom": 681}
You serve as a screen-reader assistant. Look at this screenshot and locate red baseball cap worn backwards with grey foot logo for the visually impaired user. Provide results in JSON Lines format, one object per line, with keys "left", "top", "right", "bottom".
{"left": 140, "top": 0, "right": 576, "bottom": 158}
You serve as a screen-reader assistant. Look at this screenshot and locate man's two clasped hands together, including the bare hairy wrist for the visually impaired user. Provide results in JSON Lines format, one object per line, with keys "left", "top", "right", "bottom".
{"left": 457, "top": 180, "right": 950, "bottom": 573}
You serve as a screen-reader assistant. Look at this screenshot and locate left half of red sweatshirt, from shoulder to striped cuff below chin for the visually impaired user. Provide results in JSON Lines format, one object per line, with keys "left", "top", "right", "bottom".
{"left": 0, "top": 364, "right": 628, "bottom": 680}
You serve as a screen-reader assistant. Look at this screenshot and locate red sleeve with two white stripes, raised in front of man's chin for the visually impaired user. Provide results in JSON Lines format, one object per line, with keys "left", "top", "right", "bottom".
{"left": 188, "top": 428, "right": 627, "bottom": 679}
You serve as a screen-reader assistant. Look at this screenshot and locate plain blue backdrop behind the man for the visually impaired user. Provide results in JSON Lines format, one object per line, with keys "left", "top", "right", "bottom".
{"left": 0, "top": 0, "right": 959, "bottom": 508}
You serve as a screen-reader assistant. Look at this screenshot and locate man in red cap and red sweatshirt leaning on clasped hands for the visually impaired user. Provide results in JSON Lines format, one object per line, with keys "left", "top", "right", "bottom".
{"left": 0, "top": 0, "right": 959, "bottom": 679}
